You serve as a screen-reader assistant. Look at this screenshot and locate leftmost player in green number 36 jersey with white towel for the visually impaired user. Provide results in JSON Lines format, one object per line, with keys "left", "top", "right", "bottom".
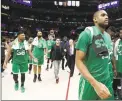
{"left": 3, "top": 31, "right": 37, "bottom": 92}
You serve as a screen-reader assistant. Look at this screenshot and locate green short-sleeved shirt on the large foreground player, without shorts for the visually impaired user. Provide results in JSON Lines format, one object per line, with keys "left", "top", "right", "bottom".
{"left": 76, "top": 26, "right": 111, "bottom": 81}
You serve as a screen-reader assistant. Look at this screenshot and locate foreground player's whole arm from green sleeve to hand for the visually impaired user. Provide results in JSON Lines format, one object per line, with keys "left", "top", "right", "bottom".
{"left": 75, "top": 32, "right": 111, "bottom": 99}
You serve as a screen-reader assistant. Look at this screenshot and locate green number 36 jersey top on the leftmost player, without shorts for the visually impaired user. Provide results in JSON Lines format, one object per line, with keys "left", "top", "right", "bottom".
{"left": 12, "top": 42, "right": 28, "bottom": 64}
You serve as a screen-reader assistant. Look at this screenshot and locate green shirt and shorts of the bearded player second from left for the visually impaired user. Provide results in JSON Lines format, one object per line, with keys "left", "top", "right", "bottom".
{"left": 32, "top": 38, "right": 46, "bottom": 66}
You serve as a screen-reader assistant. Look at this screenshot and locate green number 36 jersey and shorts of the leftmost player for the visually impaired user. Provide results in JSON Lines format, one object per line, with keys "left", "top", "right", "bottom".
{"left": 12, "top": 42, "right": 28, "bottom": 74}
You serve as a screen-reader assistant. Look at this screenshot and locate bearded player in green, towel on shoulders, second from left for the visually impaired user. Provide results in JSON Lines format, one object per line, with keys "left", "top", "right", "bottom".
{"left": 32, "top": 31, "right": 47, "bottom": 82}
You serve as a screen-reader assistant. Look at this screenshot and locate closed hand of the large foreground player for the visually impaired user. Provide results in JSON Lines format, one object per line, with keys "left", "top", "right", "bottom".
{"left": 93, "top": 82, "right": 111, "bottom": 99}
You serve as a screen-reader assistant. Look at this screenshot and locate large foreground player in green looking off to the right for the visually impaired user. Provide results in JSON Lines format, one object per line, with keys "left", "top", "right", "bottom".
{"left": 76, "top": 10, "right": 114, "bottom": 100}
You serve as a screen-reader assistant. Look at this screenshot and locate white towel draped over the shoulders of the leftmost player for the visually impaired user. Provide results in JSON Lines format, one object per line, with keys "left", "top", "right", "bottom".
{"left": 12, "top": 38, "right": 29, "bottom": 50}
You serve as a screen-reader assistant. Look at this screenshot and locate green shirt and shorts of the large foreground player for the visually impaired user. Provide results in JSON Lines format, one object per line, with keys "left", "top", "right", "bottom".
{"left": 76, "top": 26, "right": 114, "bottom": 100}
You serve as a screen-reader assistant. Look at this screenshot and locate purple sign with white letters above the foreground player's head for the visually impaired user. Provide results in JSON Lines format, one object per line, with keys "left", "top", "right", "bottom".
{"left": 98, "top": 1, "right": 119, "bottom": 10}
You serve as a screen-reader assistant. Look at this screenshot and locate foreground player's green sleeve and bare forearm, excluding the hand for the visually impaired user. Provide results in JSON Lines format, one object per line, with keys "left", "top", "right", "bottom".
{"left": 75, "top": 32, "right": 96, "bottom": 85}
